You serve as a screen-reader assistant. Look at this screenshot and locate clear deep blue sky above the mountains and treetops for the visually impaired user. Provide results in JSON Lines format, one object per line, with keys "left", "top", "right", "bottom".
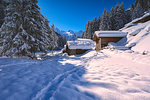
{"left": 38, "top": 0, "right": 135, "bottom": 31}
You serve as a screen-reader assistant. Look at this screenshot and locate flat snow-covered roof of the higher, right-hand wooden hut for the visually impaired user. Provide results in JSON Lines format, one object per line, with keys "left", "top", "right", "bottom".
{"left": 95, "top": 31, "right": 127, "bottom": 37}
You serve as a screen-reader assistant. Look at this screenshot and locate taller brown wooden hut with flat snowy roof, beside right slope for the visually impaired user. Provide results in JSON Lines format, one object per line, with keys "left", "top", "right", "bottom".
{"left": 93, "top": 31, "right": 127, "bottom": 51}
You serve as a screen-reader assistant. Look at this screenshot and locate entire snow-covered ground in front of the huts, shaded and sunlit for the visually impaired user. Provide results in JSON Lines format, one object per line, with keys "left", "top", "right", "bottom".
{"left": 0, "top": 50, "right": 150, "bottom": 100}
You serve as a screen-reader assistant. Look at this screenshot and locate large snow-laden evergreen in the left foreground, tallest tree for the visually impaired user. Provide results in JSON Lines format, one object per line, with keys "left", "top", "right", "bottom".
{"left": 0, "top": 0, "right": 54, "bottom": 57}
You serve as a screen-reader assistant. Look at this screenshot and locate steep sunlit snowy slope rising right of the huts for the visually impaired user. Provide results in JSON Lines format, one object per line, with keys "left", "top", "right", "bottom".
{"left": 118, "top": 14, "right": 150, "bottom": 53}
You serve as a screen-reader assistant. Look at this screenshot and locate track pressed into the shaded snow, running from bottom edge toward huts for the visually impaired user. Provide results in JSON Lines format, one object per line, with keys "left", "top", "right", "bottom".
{"left": 32, "top": 67, "right": 81, "bottom": 100}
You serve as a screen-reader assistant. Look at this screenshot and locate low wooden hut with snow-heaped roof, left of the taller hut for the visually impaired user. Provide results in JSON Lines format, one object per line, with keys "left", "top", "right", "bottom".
{"left": 63, "top": 38, "right": 95, "bottom": 55}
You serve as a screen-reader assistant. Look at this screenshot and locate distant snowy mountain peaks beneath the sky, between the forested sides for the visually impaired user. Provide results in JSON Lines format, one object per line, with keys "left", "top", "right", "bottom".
{"left": 55, "top": 28, "right": 83, "bottom": 40}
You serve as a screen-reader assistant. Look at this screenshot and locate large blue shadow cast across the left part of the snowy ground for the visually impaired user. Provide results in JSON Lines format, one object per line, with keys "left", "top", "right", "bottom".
{"left": 0, "top": 51, "right": 111, "bottom": 100}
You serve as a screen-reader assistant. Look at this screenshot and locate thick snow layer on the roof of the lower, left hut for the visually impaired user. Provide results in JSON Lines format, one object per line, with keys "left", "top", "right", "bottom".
{"left": 67, "top": 38, "right": 95, "bottom": 49}
